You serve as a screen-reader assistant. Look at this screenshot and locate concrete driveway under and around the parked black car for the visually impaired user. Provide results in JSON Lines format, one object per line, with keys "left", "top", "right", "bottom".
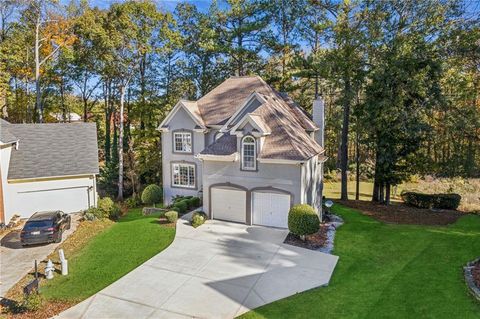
{"left": 0, "top": 214, "right": 80, "bottom": 300}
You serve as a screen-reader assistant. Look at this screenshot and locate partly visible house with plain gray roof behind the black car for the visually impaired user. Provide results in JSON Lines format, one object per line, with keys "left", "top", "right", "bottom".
{"left": 0, "top": 119, "right": 99, "bottom": 223}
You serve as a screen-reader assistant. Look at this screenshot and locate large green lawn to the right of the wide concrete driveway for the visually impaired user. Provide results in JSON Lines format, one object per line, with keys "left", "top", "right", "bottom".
{"left": 243, "top": 205, "right": 480, "bottom": 319}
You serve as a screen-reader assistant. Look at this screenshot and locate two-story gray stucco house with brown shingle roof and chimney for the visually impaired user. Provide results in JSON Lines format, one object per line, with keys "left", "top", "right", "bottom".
{"left": 159, "top": 76, "right": 326, "bottom": 228}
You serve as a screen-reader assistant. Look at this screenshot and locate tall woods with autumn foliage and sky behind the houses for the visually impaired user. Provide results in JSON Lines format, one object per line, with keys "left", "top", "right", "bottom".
{"left": 0, "top": 0, "right": 480, "bottom": 203}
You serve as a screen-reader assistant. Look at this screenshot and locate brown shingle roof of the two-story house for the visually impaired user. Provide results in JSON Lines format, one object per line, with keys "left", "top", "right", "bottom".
{"left": 197, "top": 76, "right": 323, "bottom": 161}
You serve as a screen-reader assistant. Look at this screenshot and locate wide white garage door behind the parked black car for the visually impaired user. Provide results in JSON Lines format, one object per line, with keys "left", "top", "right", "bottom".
{"left": 16, "top": 187, "right": 93, "bottom": 217}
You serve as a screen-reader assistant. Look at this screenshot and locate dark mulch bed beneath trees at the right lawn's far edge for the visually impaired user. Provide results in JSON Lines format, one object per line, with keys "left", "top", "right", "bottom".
{"left": 338, "top": 200, "right": 465, "bottom": 225}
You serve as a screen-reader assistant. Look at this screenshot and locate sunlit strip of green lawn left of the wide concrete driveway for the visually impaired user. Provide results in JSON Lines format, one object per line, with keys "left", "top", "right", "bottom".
{"left": 42, "top": 209, "right": 175, "bottom": 301}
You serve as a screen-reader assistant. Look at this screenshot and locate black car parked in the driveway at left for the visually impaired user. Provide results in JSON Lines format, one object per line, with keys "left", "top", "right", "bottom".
{"left": 20, "top": 211, "right": 72, "bottom": 246}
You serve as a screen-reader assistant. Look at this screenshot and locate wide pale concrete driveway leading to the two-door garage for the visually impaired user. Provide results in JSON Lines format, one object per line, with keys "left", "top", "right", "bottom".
{"left": 59, "top": 217, "right": 338, "bottom": 318}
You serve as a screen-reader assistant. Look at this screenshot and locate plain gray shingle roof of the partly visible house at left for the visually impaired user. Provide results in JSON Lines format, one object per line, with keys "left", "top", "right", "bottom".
{"left": 2, "top": 122, "right": 99, "bottom": 179}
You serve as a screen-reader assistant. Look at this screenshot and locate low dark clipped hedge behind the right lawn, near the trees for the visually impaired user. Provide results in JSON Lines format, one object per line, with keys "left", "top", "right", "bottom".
{"left": 401, "top": 192, "right": 462, "bottom": 209}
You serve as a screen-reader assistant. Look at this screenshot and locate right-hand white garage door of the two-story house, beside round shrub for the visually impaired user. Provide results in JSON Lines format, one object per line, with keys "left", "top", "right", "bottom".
{"left": 253, "top": 192, "right": 290, "bottom": 228}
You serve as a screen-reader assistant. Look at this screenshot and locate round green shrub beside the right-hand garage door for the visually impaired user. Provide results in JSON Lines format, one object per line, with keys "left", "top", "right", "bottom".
{"left": 288, "top": 204, "right": 320, "bottom": 236}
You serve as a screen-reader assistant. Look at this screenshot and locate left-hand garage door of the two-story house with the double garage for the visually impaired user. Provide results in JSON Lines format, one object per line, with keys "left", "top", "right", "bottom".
{"left": 212, "top": 188, "right": 247, "bottom": 223}
